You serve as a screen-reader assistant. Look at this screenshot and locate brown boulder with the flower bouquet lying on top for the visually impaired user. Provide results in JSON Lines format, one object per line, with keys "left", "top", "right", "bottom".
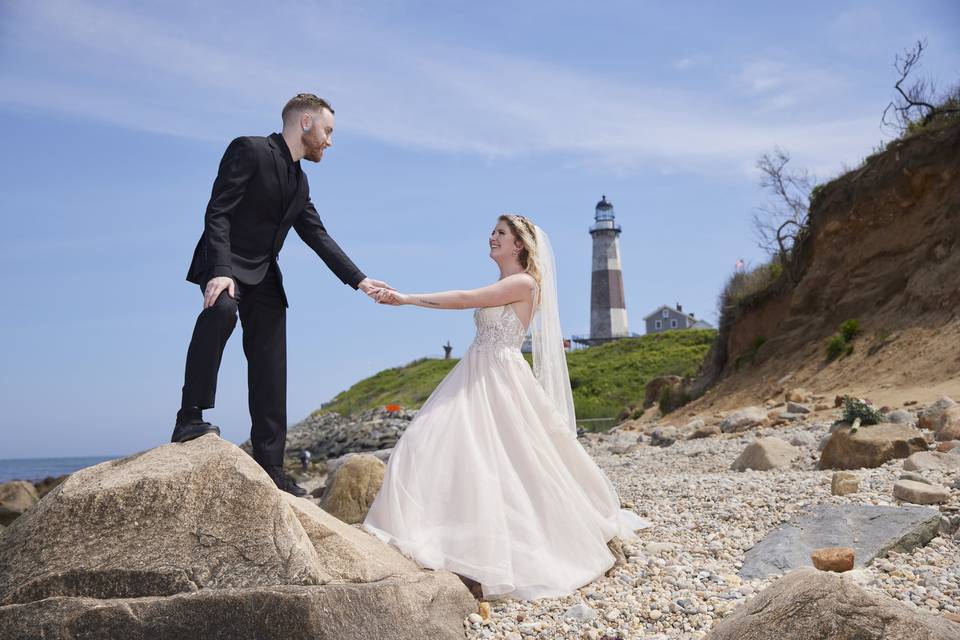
{"left": 820, "top": 422, "right": 927, "bottom": 469}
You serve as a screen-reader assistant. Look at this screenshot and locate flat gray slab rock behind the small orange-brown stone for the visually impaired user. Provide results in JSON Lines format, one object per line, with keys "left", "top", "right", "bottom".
{"left": 740, "top": 504, "right": 940, "bottom": 580}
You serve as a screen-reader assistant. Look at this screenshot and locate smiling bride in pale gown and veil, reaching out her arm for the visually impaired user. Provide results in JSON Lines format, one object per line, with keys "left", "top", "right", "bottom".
{"left": 361, "top": 215, "right": 650, "bottom": 600}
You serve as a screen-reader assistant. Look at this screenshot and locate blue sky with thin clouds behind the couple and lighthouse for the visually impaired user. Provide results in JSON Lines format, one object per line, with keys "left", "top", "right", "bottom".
{"left": 0, "top": 0, "right": 960, "bottom": 458}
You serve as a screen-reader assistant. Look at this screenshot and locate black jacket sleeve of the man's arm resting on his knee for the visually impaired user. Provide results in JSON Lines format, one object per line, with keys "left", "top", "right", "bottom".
{"left": 203, "top": 138, "right": 257, "bottom": 278}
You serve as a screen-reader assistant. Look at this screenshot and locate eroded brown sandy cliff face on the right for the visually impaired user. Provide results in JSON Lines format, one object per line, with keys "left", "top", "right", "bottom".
{"left": 691, "top": 123, "right": 960, "bottom": 408}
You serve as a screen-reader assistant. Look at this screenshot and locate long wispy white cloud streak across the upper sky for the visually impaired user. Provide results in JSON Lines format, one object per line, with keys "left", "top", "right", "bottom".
{"left": 0, "top": 1, "right": 892, "bottom": 172}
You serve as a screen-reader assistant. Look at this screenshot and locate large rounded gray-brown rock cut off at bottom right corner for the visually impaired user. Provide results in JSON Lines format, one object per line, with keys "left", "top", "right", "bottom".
{"left": 707, "top": 569, "right": 960, "bottom": 640}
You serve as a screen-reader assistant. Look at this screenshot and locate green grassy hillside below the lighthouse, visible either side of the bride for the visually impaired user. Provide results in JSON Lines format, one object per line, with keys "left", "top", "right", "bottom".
{"left": 316, "top": 329, "right": 716, "bottom": 418}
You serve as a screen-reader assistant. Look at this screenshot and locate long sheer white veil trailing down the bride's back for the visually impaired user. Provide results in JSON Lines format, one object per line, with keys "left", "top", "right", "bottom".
{"left": 531, "top": 225, "right": 577, "bottom": 435}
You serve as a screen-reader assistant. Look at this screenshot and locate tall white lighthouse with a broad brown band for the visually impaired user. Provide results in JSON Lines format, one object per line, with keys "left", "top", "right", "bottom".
{"left": 590, "top": 195, "right": 630, "bottom": 344}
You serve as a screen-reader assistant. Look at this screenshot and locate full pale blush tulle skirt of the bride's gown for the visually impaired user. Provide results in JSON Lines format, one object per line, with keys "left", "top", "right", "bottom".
{"left": 362, "top": 348, "right": 650, "bottom": 600}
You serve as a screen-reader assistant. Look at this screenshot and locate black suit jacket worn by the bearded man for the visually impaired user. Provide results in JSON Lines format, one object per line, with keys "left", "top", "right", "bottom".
{"left": 187, "top": 134, "right": 366, "bottom": 306}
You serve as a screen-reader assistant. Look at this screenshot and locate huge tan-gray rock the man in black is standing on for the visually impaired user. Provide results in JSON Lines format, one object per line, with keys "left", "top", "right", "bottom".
{"left": 0, "top": 435, "right": 476, "bottom": 639}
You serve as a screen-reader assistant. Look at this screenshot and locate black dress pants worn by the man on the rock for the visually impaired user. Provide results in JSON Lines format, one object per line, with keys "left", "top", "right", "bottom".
{"left": 181, "top": 264, "right": 287, "bottom": 466}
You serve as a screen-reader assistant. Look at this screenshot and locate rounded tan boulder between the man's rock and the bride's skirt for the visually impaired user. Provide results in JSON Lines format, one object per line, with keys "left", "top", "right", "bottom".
{"left": 320, "top": 454, "right": 387, "bottom": 524}
